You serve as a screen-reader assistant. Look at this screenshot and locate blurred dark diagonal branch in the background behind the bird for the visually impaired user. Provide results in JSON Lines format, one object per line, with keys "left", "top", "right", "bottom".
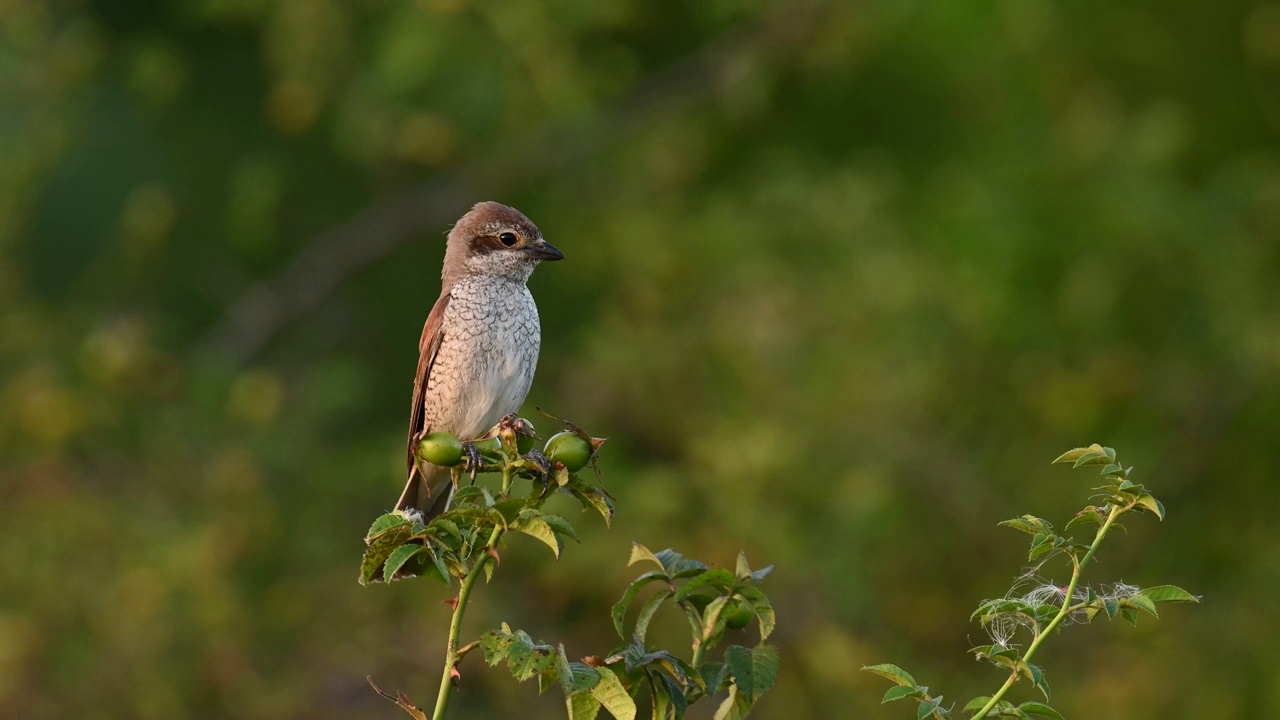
{"left": 198, "top": 1, "right": 820, "bottom": 365}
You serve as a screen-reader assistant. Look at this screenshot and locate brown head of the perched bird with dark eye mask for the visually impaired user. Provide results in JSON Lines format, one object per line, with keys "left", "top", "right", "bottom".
{"left": 443, "top": 202, "right": 564, "bottom": 283}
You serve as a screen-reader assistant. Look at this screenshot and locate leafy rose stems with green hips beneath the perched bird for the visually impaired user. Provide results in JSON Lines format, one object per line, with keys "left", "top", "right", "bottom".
{"left": 360, "top": 415, "right": 778, "bottom": 720}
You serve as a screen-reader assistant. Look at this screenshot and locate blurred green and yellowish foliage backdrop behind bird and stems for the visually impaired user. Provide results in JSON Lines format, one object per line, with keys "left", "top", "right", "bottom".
{"left": 0, "top": 0, "right": 1280, "bottom": 720}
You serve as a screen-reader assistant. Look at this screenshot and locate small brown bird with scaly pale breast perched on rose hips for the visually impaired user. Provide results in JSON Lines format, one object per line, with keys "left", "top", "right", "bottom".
{"left": 396, "top": 201, "right": 564, "bottom": 521}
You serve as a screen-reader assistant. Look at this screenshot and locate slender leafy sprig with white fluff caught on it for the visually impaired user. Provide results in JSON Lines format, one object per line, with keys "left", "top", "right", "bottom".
{"left": 863, "top": 445, "right": 1199, "bottom": 720}
